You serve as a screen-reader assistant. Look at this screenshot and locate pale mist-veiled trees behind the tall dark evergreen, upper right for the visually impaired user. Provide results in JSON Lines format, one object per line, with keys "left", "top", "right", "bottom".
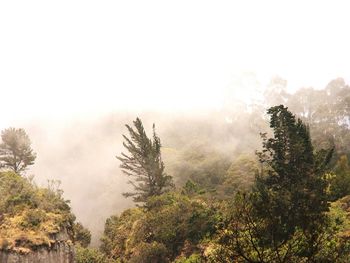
{"left": 265, "top": 78, "right": 350, "bottom": 157}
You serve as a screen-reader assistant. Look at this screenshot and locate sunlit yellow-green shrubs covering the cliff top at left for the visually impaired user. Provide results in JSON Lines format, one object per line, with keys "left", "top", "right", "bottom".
{"left": 0, "top": 172, "right": 75, "bottom": 253}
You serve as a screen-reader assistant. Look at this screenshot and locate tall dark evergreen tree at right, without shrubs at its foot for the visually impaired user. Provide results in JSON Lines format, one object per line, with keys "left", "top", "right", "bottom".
{"left": 254, "top": 105, "right": 333, "bottom": 255}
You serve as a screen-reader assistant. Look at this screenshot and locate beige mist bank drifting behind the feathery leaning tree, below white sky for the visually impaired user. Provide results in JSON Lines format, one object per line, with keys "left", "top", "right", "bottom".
{"left": 0, "top": 73, "right": 346, "bottom": 250}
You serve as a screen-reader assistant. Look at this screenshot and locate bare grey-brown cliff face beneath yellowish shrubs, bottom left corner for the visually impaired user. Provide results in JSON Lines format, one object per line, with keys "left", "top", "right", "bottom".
{"left": 0, "top": 242, "right": 74, "bottom": 263}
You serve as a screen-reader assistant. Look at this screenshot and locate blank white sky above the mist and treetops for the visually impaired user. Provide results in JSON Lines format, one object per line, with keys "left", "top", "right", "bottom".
{"left": 0, "top": 0, "right": 350, "bottom": 126}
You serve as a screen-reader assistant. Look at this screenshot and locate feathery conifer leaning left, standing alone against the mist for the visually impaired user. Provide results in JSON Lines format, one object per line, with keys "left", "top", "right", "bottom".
{"left": 117, "top": 118, "right": 173, "bottom": 203}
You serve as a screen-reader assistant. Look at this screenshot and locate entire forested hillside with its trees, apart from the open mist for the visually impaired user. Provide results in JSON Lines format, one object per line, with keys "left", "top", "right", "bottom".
{"left": 0, "top": 78, "right": 350, "bottom": 263}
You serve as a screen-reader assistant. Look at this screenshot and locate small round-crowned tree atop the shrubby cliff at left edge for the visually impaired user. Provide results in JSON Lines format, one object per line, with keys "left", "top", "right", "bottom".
{"left": 0, "top": 128, "right": 36, "bottom": 173}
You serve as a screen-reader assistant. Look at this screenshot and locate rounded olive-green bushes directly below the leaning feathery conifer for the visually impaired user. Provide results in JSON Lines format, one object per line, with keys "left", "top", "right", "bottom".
{"left": 101, "top": 193, "right": 221, "bottom": 262}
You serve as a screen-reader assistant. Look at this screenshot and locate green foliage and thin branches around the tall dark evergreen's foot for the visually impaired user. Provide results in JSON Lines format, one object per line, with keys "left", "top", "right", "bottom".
{"left": 211, "top": 194, "right": 350, "bottom": 263}
